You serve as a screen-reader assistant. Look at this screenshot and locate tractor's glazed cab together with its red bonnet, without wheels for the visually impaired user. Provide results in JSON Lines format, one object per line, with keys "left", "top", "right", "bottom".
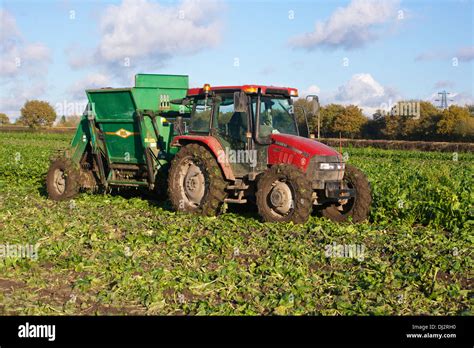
{"left": 173, "top": 84, "right": 340, "bottom": 180}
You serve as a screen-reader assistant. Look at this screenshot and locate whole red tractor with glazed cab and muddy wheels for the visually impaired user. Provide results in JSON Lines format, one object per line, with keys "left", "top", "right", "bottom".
{"left": 168, "top": 84, "right": 372, "bottom": 223}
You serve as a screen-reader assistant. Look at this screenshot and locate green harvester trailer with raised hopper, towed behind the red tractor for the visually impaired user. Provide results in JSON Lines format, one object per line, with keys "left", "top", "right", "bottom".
{"left": 47, "top": 74, "right": 190, "bottom": 200}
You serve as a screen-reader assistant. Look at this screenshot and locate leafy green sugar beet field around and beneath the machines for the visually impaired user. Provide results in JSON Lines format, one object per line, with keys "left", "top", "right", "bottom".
{"left": 0, "top": 133, "right": 474, "bottom": 315}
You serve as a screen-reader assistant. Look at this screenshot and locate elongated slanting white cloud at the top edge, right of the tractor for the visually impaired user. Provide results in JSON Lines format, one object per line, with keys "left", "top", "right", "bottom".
{"left": 290, "top": 0, "right": 399, "bottom": 50}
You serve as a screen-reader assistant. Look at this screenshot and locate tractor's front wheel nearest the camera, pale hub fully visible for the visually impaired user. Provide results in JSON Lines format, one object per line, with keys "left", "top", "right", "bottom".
{"left": 256, "top": 165, "right": 312, "bottom": 223}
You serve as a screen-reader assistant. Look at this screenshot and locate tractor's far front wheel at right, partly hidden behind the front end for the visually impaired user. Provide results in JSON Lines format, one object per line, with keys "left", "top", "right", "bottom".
{"left": 322, "top": 164, "right": 372, "bottom": 223}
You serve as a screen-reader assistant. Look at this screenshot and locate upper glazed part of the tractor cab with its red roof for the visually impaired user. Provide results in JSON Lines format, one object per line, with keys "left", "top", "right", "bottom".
{"left": 177, "top": 84, "right": 308, "bottom": 140}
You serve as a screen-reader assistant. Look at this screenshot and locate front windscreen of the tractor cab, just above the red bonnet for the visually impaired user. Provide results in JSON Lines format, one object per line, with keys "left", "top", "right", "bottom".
{"left": 252, "top": 96, "right": 298, "bottom": 138}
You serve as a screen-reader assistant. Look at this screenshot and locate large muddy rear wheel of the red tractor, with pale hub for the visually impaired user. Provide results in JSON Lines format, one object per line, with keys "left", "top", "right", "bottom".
{"left": 168, "top": 144, "right": 226, "bottom": 216}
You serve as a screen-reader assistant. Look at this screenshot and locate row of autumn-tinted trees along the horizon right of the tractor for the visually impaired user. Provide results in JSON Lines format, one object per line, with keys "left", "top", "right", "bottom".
{"left": 294, "top": 99, "right": 474, "bottom": 142}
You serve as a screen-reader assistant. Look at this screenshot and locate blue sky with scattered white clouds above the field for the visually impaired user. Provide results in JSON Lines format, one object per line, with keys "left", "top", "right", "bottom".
{"left": 0, "top": 0, "right": 474, "bottom": 120}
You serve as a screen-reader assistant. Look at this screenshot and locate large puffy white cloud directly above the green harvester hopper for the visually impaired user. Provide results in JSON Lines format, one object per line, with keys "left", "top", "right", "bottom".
{"left": 68, "top": 0, "right": 223, "bottom": 75}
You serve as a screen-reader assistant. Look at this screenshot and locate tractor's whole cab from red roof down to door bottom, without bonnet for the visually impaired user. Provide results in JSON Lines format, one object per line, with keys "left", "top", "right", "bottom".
{"left": 173, "top": 84, "right": 307, "bottom": 178}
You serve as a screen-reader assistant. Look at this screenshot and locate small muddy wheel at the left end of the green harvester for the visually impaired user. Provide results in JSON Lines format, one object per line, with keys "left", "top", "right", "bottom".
{"left": 46, "top": 158, "right": 80, "bottom": 201}
